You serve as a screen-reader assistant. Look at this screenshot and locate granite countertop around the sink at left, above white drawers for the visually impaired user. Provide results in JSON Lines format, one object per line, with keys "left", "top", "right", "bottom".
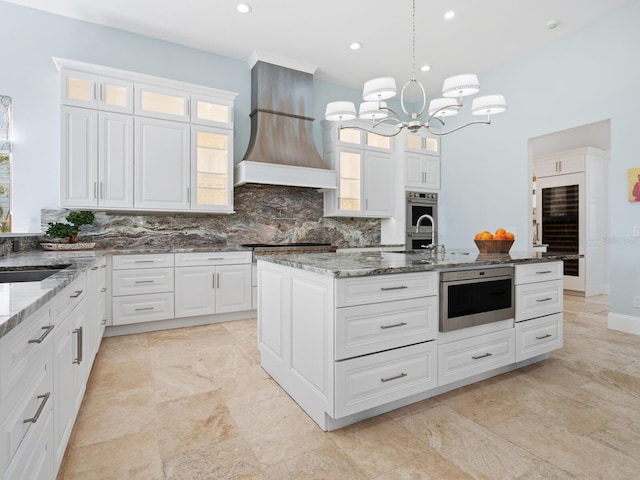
{"left": 0, "top": 250, "right": 106, "bottom": 338}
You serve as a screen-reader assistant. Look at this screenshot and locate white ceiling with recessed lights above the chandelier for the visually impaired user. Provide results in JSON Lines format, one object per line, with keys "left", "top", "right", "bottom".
{"left": 7, "top": 0, "right": 633, "bottom": 94}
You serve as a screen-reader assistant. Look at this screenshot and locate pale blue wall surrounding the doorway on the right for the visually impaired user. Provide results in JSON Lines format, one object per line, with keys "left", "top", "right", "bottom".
{"left": 440, "top": 1, "right": 640, "bottom": 321}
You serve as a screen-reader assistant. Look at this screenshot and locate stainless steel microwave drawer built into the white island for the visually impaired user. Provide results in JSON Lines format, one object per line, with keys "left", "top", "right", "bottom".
{"left": 440, "top": 266, "right": 515, "bottom": 332}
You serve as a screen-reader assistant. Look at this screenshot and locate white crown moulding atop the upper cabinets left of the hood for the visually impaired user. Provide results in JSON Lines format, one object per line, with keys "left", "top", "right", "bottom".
{"left": 52, "top": 57, "right": 239, "bottom": 101}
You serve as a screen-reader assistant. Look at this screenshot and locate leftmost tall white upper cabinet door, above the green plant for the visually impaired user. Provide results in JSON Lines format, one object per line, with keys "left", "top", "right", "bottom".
{"left": 60, "top": 107, "right": 98, "bottom": 207}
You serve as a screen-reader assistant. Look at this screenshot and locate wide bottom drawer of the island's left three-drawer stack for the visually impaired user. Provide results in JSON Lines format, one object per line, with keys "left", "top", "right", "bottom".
{"left": 332, "top": 342, "right": 437, "bottom": 418}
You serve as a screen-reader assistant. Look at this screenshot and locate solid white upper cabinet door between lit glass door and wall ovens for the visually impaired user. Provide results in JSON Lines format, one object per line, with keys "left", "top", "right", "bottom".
{"left": 364, "top": 151, "right": 394, "bottom": 217}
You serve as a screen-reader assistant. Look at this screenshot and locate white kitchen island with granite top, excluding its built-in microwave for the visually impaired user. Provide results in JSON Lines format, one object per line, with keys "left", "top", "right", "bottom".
{"left": 258, "top": 251, "right": 577, "bottom": 430}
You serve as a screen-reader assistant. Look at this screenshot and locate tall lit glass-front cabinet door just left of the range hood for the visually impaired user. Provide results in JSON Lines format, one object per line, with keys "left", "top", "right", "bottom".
{"left": 191, "top": 126, "right": 233, "bottom": 212}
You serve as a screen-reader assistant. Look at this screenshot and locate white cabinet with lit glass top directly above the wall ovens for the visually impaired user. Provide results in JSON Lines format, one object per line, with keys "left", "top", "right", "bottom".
{"left": 402, "top": 132, "right": 440, "bottom": 191}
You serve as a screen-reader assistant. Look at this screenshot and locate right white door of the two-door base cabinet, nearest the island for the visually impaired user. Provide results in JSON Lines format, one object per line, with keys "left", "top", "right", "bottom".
{"left": 216, "top": 265, "right": 251, "bottom": 313}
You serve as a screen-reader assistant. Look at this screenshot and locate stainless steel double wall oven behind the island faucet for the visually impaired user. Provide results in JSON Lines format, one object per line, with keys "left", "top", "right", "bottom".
{"left": 405, "top": 192, "right": 438, "bottom": 250}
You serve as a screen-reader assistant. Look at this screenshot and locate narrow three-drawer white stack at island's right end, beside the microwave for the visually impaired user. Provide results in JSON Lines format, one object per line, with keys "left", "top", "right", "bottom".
{"left": 515, "top": 262, "right": 563, "bottom": 362}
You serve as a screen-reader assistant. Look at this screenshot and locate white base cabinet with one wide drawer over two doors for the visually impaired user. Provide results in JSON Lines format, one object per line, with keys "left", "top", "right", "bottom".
{"left": 175, "top": 252, "right": 251, "bottom": 317}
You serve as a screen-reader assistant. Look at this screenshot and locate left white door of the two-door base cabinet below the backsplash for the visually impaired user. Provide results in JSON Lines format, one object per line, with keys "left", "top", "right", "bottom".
{"left": 175, "top": 266, "right": 216, "bottom": 317}
